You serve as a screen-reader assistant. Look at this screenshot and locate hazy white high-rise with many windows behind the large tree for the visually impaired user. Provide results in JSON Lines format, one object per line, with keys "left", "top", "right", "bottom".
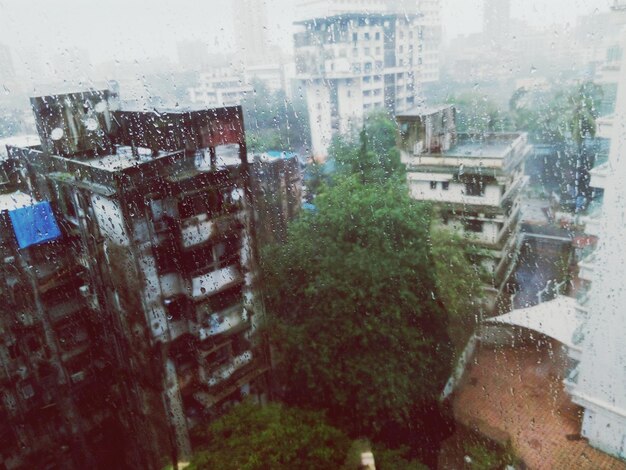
{"left": 294, "top": 0, "right": 441, "bottom": 157}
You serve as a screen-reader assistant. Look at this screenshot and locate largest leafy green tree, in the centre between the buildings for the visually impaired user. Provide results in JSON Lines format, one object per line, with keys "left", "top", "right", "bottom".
{"left": 263, "top": 177, "right": 450, "bottom": 435}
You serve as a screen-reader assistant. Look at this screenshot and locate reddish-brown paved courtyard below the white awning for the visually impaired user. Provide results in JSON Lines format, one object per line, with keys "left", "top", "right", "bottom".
{"left": 453, "top": 344, "right": 626, "bottom": 470}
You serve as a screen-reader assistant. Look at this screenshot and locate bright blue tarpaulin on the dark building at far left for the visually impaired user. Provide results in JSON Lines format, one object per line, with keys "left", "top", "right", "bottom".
{"left": 9, "top": 201, "right": 61, "bottom": 248}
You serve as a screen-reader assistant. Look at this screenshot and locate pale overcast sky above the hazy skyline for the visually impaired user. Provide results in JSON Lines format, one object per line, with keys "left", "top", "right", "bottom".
{"left": 0, "top": 0, "right": 612, "bottom": 66}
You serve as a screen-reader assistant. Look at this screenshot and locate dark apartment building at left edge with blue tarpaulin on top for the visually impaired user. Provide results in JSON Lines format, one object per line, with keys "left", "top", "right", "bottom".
{"left": 0, "top": 160, "right": 124, "bottom": 469}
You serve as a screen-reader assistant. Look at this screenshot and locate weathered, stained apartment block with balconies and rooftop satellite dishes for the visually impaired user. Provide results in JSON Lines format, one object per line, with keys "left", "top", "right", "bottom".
{"left": 2, "top": 90, "right": 268, "bottom": 469}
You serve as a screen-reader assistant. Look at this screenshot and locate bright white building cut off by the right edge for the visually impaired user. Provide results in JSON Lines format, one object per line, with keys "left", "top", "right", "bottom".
{"left": 565, "top": 26, "right": 626, "bottom": 459}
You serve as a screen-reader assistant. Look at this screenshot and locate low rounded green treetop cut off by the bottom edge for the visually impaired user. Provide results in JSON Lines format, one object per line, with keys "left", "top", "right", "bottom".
{"left": 188, "top": 402, "right": 350, "bottom": 470}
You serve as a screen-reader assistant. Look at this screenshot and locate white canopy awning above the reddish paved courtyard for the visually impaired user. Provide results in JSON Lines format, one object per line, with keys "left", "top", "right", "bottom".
{"left": 483, "top": 296, "right": 582, "bottom": 348}
